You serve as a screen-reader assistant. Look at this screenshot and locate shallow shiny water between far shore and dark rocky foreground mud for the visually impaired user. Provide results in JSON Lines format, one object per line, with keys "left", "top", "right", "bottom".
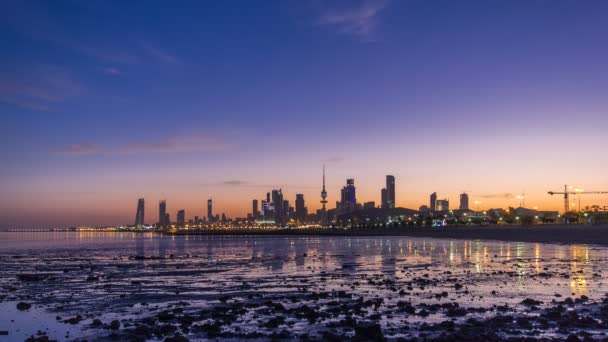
{"left": 0, "top": 232, "right": 608, "bottom": 341}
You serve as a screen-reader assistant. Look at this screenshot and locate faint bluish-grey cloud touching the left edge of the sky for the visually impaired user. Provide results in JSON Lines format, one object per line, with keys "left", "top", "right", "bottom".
{"left": 0, "top": 64, "right": 82, "bottom": 111}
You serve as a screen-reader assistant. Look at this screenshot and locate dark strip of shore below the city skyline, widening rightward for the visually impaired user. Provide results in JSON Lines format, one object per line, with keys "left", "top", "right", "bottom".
{"left": 167, "top": 225, "right": 608, "bottom": 246}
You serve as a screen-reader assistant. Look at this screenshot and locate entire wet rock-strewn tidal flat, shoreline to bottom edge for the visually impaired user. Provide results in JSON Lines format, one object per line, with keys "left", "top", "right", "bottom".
{"left": 0, "top": 233, "right": 608, "bottom": 341}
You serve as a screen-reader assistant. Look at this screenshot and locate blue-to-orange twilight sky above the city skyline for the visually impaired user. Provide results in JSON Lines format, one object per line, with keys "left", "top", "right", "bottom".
{"left": 0, "top": 0, "right": 608, "bottom": 228}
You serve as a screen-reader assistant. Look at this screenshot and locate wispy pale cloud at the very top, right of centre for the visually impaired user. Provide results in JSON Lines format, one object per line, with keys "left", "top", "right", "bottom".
{"left": 318, "top": 0, "right": 388, "bottom": 40}
